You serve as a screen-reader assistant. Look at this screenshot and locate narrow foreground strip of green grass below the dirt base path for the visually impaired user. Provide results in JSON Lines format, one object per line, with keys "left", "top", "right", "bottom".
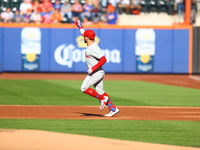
{"left": 0, "top": 119, "right": 200, "bottom": 147}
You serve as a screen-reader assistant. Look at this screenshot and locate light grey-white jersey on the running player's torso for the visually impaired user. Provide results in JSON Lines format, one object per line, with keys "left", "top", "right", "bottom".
{"left": 85, "top": 43, "right": 104, "bottom": 69}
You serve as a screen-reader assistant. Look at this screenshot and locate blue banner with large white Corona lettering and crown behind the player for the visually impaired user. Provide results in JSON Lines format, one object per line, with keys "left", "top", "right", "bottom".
{"left": 50, "top": 29, "right": 123, "bottom": 72}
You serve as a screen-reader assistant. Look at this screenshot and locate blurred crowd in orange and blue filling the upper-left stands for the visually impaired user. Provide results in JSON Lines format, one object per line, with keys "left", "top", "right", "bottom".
{"left": 0, "top": 0, "right": 118, "bottom": 25}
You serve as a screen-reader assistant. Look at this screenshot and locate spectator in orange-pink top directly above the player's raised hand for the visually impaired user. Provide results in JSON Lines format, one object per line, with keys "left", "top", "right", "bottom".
{"left": 72, "top": 0, "right": 83, "bottom": 20}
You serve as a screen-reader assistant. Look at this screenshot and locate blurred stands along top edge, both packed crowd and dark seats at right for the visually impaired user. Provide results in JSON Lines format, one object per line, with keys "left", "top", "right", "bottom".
{"left": 0, "top": 0, "right": 197, "bottom": 25}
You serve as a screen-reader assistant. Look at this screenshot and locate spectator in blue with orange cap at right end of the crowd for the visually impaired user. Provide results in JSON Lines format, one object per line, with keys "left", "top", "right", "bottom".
{"left": 107, "top": 4, "right": 118, "bottom": 24}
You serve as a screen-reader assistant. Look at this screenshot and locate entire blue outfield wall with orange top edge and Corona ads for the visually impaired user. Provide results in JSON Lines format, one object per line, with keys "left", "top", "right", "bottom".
{"left": 0, "top": 24, "right": 191, "bottom": 74}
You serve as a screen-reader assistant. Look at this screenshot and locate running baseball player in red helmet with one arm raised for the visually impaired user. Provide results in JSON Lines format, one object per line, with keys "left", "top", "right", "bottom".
{"left": 74, "top": 19, "right": 119, "bottom": 117}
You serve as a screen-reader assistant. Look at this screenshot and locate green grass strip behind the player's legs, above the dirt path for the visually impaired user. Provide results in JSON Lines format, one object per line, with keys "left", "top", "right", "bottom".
{"left": 0, "top": 80, "right": 200, "bottom": 107}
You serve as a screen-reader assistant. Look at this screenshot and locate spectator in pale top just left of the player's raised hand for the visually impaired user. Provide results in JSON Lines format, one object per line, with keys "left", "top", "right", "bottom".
{"left": 61, "top": 0, "right": 72, "bottom": 22}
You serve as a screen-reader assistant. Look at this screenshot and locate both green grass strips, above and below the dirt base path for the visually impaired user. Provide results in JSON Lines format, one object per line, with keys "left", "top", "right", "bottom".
{"left": 0, "top": 80, "right": 200, "bottom": 147}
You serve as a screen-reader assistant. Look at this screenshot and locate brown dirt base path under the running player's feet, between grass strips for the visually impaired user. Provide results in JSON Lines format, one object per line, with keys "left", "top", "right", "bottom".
{"left": 0, "top": 105, "right": 200, "bottom": 121}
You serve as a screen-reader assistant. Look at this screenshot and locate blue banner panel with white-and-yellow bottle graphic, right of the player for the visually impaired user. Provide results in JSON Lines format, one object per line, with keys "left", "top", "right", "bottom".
{"left": 123, "top": 28, "right": 174, "bottom": 73}
